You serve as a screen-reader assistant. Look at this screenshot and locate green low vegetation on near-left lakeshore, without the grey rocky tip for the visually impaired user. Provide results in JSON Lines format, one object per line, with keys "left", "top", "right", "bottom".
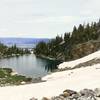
{"left": 0, "top": 68, "right": 32, "bottom": 86}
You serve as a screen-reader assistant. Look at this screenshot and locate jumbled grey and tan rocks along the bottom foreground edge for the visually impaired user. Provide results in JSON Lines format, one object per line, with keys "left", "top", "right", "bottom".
{"left": 30, "top": 88, "right": 100, "bottom": 100}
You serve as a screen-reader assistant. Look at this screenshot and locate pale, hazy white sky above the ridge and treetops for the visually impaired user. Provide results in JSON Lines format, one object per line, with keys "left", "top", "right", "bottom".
{"left": 0, "top": 0, "right": 100, "bottom": 38}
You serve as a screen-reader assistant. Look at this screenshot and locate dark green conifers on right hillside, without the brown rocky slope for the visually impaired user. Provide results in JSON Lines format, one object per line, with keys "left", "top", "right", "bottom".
{"left": 34, "top": 20, "right": 100, "bottom": 60}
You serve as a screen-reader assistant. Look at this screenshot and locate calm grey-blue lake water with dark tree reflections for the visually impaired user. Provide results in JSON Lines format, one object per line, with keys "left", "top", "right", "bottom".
{"left": 0, "top": 54, "right": 59, "bottom": 78}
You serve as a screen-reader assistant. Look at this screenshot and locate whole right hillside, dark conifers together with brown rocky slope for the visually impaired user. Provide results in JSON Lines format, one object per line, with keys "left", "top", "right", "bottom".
{"left": 34, "top": 20, "right": 100, "bottom": 61}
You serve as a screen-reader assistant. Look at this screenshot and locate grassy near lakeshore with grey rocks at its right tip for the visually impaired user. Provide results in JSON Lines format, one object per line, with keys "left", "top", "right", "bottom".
{"left": 0, "top": 68, "right": 45, "bottom": 87}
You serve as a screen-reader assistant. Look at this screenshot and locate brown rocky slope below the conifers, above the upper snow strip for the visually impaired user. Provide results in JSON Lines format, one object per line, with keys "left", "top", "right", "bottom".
{"left": 71, "top": 41, "right": 100, "bottom": 60}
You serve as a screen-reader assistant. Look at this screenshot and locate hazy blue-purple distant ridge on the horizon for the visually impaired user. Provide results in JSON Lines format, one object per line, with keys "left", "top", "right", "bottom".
{"left": 0, "top": 37, "right": 49, "bottom": 47}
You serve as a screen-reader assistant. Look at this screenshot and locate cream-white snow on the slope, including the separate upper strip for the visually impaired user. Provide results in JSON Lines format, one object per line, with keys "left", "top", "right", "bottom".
{"left": 0, "top": 51, "right": 100, "bottom": 100}
